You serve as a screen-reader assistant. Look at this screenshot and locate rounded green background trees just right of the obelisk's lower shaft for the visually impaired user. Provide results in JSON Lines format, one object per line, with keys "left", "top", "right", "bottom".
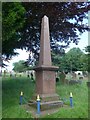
{"left": 52, "top": 48, "right": 88, "bottom": 72}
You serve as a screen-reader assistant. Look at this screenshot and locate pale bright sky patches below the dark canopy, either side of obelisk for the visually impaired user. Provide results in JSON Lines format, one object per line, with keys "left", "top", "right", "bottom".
{"left": 5, "top": 32, "right": 88, "bottom": 71}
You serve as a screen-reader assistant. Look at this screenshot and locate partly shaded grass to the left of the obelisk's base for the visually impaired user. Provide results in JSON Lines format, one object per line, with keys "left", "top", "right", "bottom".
{"left": 2, "top": 77, "right": 35, "bottom": 118}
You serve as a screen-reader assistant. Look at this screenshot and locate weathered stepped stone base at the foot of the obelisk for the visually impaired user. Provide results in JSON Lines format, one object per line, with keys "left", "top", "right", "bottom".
{"left": 28, "top": 94, "right": 63, "bottom": 111}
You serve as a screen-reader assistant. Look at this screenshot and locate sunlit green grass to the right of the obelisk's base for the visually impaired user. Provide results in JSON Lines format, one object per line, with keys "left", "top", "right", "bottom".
{"left": 45, "top": 80, "right": 88, "bottom": 118}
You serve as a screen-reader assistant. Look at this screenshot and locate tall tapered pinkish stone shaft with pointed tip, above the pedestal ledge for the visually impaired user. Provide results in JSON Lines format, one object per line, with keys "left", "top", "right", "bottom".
{"left": 39, "top": 16, "right": 51, "bottom": 66}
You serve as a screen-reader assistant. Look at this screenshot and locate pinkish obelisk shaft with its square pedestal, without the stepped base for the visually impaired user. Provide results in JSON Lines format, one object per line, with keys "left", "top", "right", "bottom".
{"left": 35, "top": 16, "right": 58, "bottom": 96}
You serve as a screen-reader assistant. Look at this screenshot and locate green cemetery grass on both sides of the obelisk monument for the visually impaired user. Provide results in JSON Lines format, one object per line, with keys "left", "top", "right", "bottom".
{"left": 2, "top": 76, "right": 88, "bottom": 118}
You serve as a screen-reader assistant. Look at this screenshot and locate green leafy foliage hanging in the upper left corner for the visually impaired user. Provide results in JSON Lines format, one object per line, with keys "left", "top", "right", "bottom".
{"left": 2, "top": 2, "right": 25, "bottom": 57}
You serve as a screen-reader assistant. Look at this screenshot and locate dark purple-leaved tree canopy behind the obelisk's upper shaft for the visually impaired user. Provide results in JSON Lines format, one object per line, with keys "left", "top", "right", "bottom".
{"left": 2, "top": 2, "right": 90, "bottom": 63}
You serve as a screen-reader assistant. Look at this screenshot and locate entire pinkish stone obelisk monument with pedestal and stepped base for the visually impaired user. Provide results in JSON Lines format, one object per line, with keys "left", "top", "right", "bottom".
{"left": 29, "top": 16, "right": 63, "bottom": 110}
